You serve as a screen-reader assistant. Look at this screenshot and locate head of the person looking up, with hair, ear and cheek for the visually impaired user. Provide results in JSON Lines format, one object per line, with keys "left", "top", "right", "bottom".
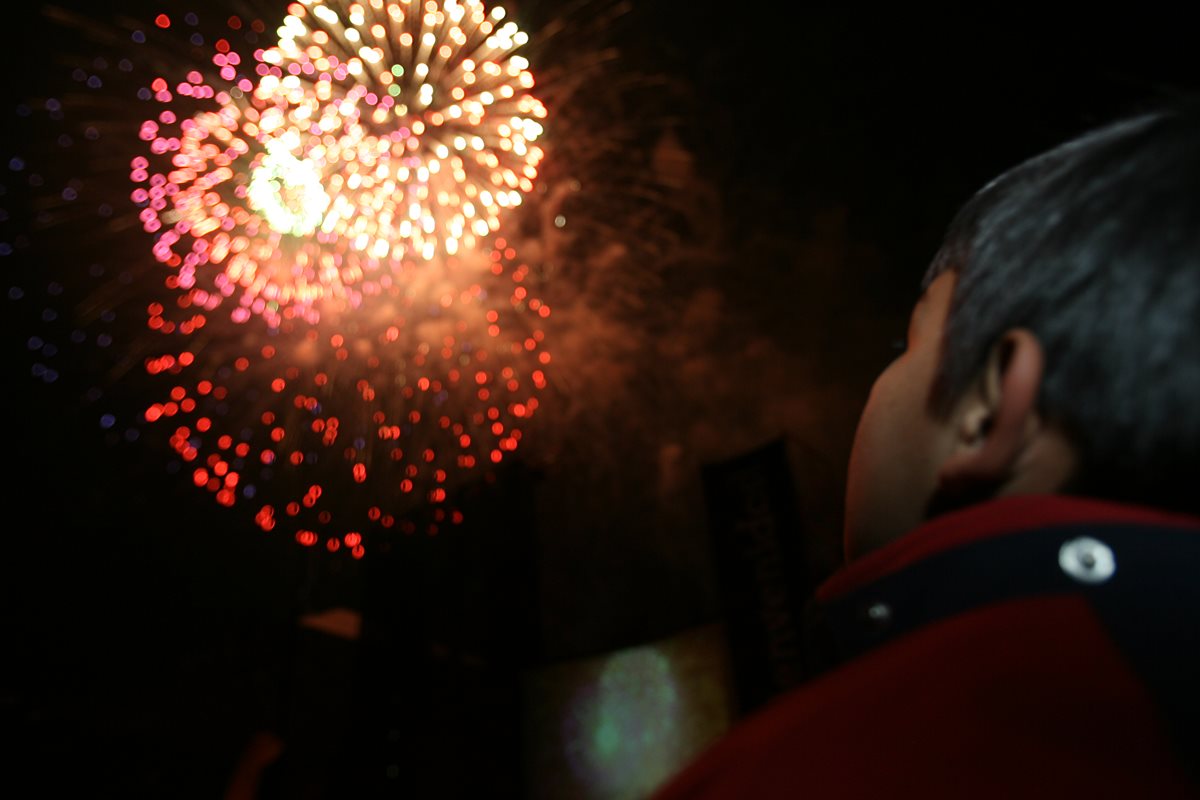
{"left": 845, "top": 103, "right": 1200, "bottom": 559}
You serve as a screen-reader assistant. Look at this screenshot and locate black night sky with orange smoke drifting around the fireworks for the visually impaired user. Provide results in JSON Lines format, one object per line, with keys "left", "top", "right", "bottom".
{"left": 0, "top": 0, "right": 1200, "bottom": 798}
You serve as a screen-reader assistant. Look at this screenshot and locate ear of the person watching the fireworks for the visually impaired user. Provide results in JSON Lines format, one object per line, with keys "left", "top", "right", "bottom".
{"left": 937, "top": 329, "right": 1045, "bottom": 495}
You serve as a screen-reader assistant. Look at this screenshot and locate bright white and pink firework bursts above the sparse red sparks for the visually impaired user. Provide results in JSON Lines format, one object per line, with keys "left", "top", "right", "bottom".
{"left": 131, "top": 0, "right": 546, "bottom": 325}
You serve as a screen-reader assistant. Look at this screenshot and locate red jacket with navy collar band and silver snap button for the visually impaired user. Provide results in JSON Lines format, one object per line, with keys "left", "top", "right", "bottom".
{"left": 656, "top": 495, "right": 1200, "bottom": 800}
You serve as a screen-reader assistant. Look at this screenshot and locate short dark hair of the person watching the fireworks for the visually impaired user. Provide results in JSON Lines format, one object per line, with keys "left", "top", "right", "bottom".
{"left": 924, "top": 100, "right": 1200, "bottom": 512}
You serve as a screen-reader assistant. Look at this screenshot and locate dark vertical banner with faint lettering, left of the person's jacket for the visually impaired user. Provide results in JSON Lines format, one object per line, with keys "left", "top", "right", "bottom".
{"left": 702, "top": 438, "right": 812, "bottom": 714}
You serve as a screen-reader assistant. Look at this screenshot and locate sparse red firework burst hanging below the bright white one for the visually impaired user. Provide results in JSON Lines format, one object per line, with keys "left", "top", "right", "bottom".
{"left": 145, "top": 240, "right": 548, "bottom": 549}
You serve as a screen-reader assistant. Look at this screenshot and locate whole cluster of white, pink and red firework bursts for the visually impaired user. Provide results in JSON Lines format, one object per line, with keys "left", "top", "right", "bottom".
{"left": 3, "top": 0, "right": 550, "bottom": 555}
